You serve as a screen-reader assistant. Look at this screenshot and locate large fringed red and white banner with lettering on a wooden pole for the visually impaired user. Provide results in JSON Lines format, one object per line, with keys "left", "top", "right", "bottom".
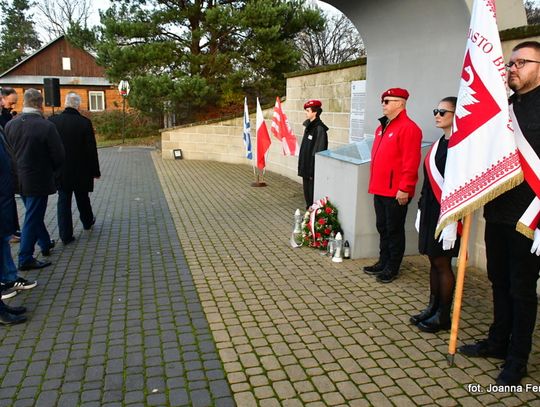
{"left": 436, "top": 0, "right": 523, "bottom": 235}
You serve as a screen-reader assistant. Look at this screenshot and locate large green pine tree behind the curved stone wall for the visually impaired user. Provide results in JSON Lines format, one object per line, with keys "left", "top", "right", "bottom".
{"left": 97, "top": 0, "right": 323, "bottom": 121}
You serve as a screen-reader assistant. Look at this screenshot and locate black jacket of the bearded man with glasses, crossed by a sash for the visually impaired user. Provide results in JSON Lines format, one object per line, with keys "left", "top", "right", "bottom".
{"left": 484, "top": 86, "right": 540, "bottom": 226}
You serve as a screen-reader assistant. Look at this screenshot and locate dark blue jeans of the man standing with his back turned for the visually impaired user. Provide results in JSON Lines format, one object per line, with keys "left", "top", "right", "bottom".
{"left": 19, "top": 196, "right": 51, "bottom": 266}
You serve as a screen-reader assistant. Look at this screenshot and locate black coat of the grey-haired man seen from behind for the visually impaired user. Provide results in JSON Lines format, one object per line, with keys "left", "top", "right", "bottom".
{"left": 49, "top": 107, "right": 101, "bottom": 192}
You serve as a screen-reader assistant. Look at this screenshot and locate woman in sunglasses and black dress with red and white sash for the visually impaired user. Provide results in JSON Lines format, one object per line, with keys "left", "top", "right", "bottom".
{"left": 410, "top": 96, "right": 459, "bottom": 333}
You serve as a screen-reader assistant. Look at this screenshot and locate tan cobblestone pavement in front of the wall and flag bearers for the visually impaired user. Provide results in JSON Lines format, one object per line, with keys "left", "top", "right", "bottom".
{"left": 153, "top": 153, "right": 540, "bottom": 407}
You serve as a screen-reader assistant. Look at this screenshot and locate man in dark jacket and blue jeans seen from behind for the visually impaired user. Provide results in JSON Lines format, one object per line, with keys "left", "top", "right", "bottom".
{"left": 6, "top": 88, "right": 64, "bottom": 270}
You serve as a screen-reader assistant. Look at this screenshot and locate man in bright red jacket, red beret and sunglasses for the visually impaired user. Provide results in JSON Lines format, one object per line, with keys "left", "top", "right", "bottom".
{"left": 364, "top": 88, "right": 422, "bottom": 283}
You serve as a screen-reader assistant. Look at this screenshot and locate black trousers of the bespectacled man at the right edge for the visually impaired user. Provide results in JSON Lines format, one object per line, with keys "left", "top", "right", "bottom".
{"left": 485, "top": 223, "right": 540, "bottom": 363}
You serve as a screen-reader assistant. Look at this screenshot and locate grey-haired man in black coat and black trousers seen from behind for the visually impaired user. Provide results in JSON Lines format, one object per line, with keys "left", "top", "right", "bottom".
{"left": 49, "top": 93, "right": 101, "bottom": 244}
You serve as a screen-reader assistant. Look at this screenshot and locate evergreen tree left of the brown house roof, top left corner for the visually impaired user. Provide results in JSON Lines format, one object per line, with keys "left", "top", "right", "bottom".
{"left": 0, "top": 0, "right": 41, "bottom": 72}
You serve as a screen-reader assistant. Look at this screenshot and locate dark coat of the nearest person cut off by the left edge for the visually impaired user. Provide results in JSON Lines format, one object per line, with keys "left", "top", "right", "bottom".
{"left": 0, "top": 130, "right": 17, "bottom": 237}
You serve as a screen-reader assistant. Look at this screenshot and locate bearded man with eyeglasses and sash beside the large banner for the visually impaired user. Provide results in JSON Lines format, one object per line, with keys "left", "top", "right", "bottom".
{"left": 458, "top": 41, "right": 540, "bottom": 385}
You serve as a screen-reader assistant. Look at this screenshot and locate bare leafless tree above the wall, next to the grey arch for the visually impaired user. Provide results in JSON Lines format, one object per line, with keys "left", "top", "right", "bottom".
{"left": 296, "top": 14, "right": 366, "bottom": 69}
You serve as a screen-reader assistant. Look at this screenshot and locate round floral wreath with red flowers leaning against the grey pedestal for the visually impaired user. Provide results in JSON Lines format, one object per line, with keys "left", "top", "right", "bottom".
{"left": 302, "top": 197, "right": 341, "bottom": 250}
